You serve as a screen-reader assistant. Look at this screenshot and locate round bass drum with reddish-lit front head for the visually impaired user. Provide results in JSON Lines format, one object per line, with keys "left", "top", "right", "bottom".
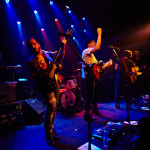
{"left": 60, "top": 90, "right": 76, "bottom": 110}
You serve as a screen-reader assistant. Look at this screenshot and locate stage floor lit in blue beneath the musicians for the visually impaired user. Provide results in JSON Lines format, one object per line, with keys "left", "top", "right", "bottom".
{"left": 0, "top": 102, "right": 150, "bottom": 150}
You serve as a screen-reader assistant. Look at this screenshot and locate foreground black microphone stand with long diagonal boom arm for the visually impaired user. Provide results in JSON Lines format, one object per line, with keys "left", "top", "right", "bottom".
{"left": 66, "top": 36, "right": 112, "bottom": 150}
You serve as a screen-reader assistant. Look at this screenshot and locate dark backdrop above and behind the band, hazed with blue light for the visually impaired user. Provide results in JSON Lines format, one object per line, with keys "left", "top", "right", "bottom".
{"left": 0, "top": 0, "right": 150, "bottom": 97}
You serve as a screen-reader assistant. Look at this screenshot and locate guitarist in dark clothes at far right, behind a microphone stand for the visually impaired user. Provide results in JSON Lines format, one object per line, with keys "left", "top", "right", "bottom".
{"left": 115, "top": 50, "right": 137, "bottom": 109}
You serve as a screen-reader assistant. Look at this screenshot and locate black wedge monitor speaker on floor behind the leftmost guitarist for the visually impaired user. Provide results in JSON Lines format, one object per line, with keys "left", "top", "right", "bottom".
{"left": 23, "top": 99, "right": 45, "bottom": 116}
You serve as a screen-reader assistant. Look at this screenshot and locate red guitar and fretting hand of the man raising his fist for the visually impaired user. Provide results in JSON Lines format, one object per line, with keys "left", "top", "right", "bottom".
{"left": 91, "top": 59, "right": 112, "bottom": 81}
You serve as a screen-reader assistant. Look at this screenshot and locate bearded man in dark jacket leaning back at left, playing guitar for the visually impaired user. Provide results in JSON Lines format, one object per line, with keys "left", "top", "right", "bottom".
{"left": 26, "top": 38, "right": 66, "bottom": 145}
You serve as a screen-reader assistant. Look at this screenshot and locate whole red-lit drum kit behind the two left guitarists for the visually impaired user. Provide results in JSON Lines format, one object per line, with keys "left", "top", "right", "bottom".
{"left": 59, "top": 69, "right": 82, "bottom": 111}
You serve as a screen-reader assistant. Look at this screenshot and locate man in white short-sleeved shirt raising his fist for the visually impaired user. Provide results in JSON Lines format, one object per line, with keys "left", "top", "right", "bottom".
{"left": 82, "top": 28, "right": 102, "bottom": 121}
